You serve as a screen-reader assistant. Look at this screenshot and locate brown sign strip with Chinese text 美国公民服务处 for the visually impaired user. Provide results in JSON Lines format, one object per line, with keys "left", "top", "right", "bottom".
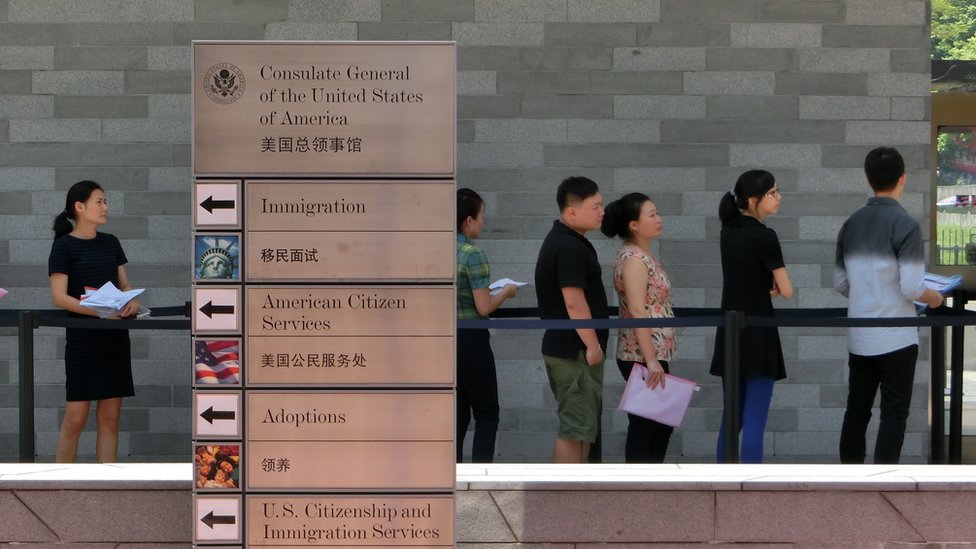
{"left": 244, "top": 336, "right": 454, "bottom": 387}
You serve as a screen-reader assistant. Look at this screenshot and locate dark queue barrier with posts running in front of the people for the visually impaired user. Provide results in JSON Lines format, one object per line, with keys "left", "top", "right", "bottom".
{"left": 7, "top": 296, "right": 976, "bottom": 463}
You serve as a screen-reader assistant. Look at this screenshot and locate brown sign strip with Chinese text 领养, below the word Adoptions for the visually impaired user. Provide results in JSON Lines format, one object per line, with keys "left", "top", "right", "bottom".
{"left": 245, "top": 438, "right": 455, "bottom": 492}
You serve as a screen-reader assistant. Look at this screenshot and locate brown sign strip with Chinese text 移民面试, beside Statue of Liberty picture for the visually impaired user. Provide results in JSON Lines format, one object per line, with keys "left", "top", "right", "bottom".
{"left": 244, "top": 231, "right": 457, "bottom": 282}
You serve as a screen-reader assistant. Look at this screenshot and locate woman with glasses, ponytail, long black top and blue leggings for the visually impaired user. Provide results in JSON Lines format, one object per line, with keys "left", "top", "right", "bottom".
{"left": 710, "top": 170, "right": 793, "bottom": 463}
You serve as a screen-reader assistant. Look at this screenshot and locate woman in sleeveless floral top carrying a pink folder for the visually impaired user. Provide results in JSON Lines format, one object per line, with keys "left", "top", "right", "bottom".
{"left": 600, "top": 193, "right": 675, "bottom": 463}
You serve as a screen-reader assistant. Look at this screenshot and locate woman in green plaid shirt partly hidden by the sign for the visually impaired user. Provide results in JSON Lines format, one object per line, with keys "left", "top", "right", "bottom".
{"left": 457, "top": 189, "right": 518, "bottom": 463}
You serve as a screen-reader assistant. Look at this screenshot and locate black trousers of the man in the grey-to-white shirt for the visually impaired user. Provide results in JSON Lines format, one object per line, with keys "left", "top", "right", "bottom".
{"left": 840, "top": 345, "right": 918, "bottom": 464}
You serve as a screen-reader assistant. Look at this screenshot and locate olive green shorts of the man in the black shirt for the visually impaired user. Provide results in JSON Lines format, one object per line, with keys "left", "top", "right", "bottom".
{"left": 542, "top": 351, "right": 603, "bottom": 442}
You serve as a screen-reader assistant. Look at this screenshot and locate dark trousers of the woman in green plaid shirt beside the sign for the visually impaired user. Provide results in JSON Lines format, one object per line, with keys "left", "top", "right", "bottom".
{"left": 457, "top": 330, "right": 498, "bottom": 463}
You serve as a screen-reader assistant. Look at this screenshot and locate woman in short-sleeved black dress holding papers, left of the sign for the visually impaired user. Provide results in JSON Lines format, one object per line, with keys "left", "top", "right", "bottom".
{"left": 48, "top": 181, "right": 139, "bottom": 463}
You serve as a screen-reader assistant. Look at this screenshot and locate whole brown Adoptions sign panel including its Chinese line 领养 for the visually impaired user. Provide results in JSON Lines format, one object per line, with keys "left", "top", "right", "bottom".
{"left": 247, "top": 391, "right": 454, "bottom": 491}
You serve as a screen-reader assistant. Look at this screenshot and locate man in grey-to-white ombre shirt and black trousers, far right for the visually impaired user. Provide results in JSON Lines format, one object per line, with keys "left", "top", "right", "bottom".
{"left": 834, "top": 147, "right": 943, "bottom": 463}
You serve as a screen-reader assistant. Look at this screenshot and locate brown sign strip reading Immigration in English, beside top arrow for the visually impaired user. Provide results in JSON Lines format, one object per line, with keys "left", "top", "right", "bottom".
{"left": 245, "top": 180, "right": 456, "bottom": 233}
